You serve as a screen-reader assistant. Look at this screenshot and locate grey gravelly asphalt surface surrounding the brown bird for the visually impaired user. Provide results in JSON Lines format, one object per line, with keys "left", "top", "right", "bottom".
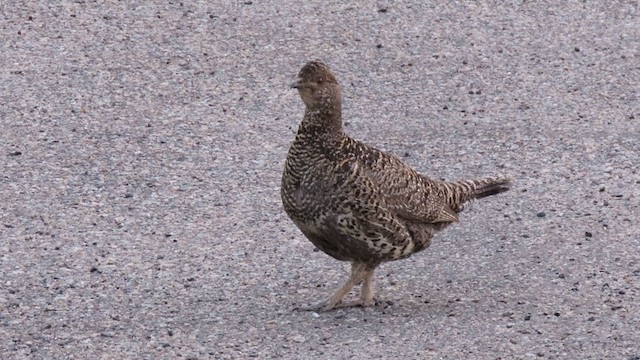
{"left": 0, "top": 0, "right": 640, "bottom": 360}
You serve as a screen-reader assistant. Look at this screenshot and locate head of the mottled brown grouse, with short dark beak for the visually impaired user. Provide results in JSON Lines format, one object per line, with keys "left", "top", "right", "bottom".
{"left": 291, "top": 61, "right": 341, "bottom": 109}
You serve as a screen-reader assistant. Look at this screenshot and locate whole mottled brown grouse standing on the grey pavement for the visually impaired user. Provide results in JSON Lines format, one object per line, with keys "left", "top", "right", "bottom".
{"left": 281, "top": 61, "right": 511, "bottom": 310}
